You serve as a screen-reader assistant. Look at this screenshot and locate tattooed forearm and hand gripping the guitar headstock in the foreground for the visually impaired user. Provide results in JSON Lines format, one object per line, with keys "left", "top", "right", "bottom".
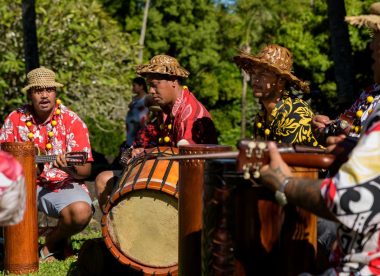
{"left": 260, "top": 143, "right": 336, "bottom": 221}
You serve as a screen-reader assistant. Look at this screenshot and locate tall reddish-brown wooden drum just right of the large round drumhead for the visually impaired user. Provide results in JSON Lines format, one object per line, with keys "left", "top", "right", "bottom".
{"left": 178, "top": 145, "right": 231, "bottom": 276}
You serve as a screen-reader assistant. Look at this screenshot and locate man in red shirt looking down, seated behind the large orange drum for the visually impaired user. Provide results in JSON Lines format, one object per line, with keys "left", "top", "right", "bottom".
{"left": 95, "top": 55, "right": 217, "bottom": 209}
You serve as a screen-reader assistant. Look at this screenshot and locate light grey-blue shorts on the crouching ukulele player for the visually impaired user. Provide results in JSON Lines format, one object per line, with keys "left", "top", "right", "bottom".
{"left": 37, "top": 183, "right": 93, "bottom": 218}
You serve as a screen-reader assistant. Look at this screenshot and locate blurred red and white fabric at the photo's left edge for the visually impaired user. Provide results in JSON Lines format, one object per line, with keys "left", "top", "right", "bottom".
{"left": 0, "top": 151, "right": 26, "bottom": 226}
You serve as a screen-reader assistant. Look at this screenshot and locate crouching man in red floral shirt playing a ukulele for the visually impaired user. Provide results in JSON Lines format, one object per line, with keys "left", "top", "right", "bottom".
{"left": 0, "top": 67, "right": 93, "bottom": 259}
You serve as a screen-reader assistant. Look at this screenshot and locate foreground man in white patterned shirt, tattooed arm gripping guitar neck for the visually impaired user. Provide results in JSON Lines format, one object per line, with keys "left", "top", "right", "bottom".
{"left": 260, "top": 102, "right": 380, "bottom": 275}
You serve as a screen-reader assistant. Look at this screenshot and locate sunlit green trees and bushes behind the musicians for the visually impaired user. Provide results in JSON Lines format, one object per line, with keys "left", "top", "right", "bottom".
{"left": 0, "top": 0, "right": 374, "bottom": 156}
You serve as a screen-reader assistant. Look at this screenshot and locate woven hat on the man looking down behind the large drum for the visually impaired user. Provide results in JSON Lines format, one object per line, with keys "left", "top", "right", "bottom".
{"left": 136, "top": 55, "right": 190, "bottom": 78}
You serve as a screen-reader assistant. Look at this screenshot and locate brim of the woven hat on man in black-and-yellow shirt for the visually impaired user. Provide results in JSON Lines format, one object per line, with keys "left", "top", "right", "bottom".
{"left": 234, "top": 53, "right": 310, "bottom": 92}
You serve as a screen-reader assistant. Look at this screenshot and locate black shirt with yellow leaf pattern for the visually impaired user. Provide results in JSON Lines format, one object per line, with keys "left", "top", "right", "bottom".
{"left": 253, "top": 96, "right": 318, "bottom": 147}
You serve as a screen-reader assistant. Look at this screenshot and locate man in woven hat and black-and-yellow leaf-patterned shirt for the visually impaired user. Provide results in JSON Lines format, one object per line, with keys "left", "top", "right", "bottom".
{"left": 234, "top": 44, "right": 318, "bottom": 146}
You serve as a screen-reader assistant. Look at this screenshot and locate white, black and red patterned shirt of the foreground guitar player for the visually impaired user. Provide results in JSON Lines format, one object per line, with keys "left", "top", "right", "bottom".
{"left": 321, "top": 105, "right": 380, "bottom": 275}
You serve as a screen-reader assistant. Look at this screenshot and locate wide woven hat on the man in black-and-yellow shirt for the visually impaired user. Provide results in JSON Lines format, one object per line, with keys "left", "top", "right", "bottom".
{"left": 234, "top": 44, "right": 309, "bottom": 92}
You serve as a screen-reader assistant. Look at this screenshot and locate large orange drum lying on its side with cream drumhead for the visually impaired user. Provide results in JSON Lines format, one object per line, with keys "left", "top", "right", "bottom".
{"left": 102, "top": 147, "right": 178, "bottom": 275}
